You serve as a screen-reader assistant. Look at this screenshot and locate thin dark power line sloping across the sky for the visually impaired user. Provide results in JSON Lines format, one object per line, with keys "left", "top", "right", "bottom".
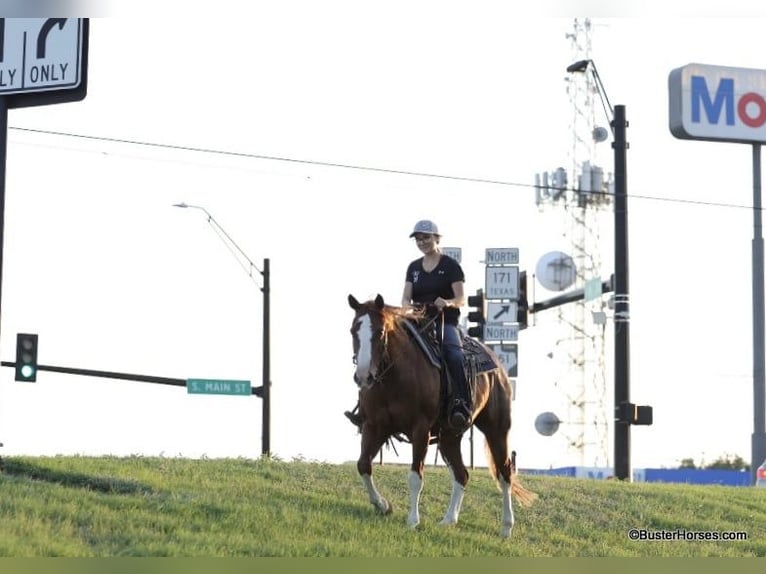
{"left": 9, "top": 126, "right": 766, "bottom": 211}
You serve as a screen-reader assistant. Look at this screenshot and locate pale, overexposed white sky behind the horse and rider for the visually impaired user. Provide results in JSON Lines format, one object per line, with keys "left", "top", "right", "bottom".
{"left": 0, "top": 0, "right": 766, "bottom": 474}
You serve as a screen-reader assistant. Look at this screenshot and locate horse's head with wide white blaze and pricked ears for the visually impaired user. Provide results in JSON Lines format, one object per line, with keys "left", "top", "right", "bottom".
{"left": 348, "top": 295, "right": 386, "bottom": 386}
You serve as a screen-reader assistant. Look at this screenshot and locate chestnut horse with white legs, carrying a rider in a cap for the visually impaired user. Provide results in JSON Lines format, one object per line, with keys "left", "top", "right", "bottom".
{"left": 348, "top": 295, "right": 537, "bottom": 537}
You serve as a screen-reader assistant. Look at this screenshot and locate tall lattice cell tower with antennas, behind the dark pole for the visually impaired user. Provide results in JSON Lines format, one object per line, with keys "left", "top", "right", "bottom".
{"left": 535, "top": 18, "right": 612, "bottom": 466}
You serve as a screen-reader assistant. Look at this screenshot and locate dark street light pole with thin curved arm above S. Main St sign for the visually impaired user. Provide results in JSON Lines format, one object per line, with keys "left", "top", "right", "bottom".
{"left": 173, "top": 203, "right": 271, "bottom": 457}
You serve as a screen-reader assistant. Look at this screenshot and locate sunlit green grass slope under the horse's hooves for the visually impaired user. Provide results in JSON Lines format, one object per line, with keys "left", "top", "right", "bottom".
{"left": 0, "top": 457, "right": 766, "bottom": 557}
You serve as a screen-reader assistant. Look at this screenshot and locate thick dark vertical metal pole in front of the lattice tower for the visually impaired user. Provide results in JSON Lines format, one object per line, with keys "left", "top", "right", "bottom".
{"left": 612, "top": 105, "right": 633, "bottom": 482}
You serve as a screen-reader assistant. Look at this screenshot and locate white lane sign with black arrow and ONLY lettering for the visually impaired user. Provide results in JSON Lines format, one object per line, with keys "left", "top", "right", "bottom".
{"left": 0, "top": 18, "right": 85, "bottom": 95}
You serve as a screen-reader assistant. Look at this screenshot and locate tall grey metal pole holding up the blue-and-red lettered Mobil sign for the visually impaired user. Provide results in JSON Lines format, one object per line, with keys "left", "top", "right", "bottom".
{"left": 750, "top": 143, "right": 766, "bottom": 484}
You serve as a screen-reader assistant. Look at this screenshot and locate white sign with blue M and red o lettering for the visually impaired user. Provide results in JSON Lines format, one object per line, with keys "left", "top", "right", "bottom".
{"left": 668, "top": 64, "right": 766, "bottom": 143}
